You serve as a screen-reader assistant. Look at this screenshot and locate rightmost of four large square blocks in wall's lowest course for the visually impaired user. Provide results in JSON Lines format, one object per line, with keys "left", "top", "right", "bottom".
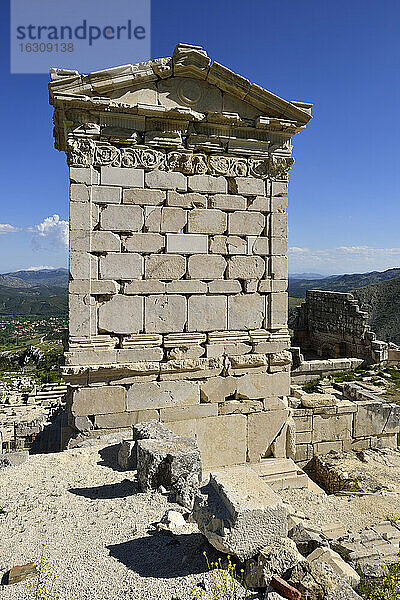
{"left": 228, "top": 294, "right": 265, "bottom": 330}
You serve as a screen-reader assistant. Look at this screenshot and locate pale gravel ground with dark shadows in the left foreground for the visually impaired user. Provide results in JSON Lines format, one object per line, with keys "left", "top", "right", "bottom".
{"left": 0, "top": 446, "right": 250, "bottom": 600}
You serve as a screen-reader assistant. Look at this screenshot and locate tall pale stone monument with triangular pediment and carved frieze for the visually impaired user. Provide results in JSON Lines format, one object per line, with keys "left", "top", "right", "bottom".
{"left": 49, "top": 44, "right": 311, "bottom": 466}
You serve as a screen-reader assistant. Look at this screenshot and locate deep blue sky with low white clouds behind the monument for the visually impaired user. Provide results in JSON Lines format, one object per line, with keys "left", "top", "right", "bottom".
{"left": 0, "top": 0, "right": 400, "bottom": 274}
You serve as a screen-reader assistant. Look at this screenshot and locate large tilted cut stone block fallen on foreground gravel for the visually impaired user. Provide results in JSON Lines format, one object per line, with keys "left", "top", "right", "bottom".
{"left": 193, "top": 467, "right": 287, "bottom": 560}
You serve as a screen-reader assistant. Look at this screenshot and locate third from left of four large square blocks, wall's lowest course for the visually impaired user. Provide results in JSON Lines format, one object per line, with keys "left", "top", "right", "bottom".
{"left": 187, "top": 296, "right": 227, "bottom": 331}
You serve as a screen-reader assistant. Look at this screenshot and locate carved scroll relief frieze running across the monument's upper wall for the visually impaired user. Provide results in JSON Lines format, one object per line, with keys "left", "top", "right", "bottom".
{"left": 68, "top": 137, "right": 294, "bottom": 180}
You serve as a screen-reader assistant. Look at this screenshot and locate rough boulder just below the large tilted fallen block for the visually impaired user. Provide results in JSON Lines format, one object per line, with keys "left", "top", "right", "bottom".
{"left": 245, "top": 537, "right": 303, "bottom": 588}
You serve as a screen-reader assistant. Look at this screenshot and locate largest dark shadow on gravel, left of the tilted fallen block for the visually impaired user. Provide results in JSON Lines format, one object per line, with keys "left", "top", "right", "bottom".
{"left": 107, "top": 533, "right": 210, "bottom": 579}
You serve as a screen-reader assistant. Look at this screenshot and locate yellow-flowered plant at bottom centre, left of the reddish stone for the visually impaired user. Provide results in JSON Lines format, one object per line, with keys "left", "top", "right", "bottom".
{"left": 192, "top": 552, "right": 250, "bottom": 600}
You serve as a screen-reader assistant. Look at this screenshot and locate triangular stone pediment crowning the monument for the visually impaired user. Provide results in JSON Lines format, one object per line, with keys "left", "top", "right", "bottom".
{"left": 49, "top": 44, "right": 312, "bottom": 128}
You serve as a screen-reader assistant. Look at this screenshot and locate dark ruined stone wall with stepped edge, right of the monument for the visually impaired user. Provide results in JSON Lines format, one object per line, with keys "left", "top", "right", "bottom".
{"left": 293, "top": 290, "right": 387, "bottom": 363}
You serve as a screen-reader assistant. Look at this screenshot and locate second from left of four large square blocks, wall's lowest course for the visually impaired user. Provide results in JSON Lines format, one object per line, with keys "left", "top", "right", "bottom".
{"left": 145, "top": 294, "right": 186, "bottom": 333}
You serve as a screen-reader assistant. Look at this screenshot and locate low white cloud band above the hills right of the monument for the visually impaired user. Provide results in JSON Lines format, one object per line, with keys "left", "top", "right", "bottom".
{"left": 289, "top": 246, "right": 400, "bottom": 273}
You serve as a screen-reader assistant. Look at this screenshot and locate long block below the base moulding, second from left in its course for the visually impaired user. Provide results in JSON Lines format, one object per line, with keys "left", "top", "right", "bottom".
{"left": 127, "top": 381, "right": 200, "bottom": 411}
